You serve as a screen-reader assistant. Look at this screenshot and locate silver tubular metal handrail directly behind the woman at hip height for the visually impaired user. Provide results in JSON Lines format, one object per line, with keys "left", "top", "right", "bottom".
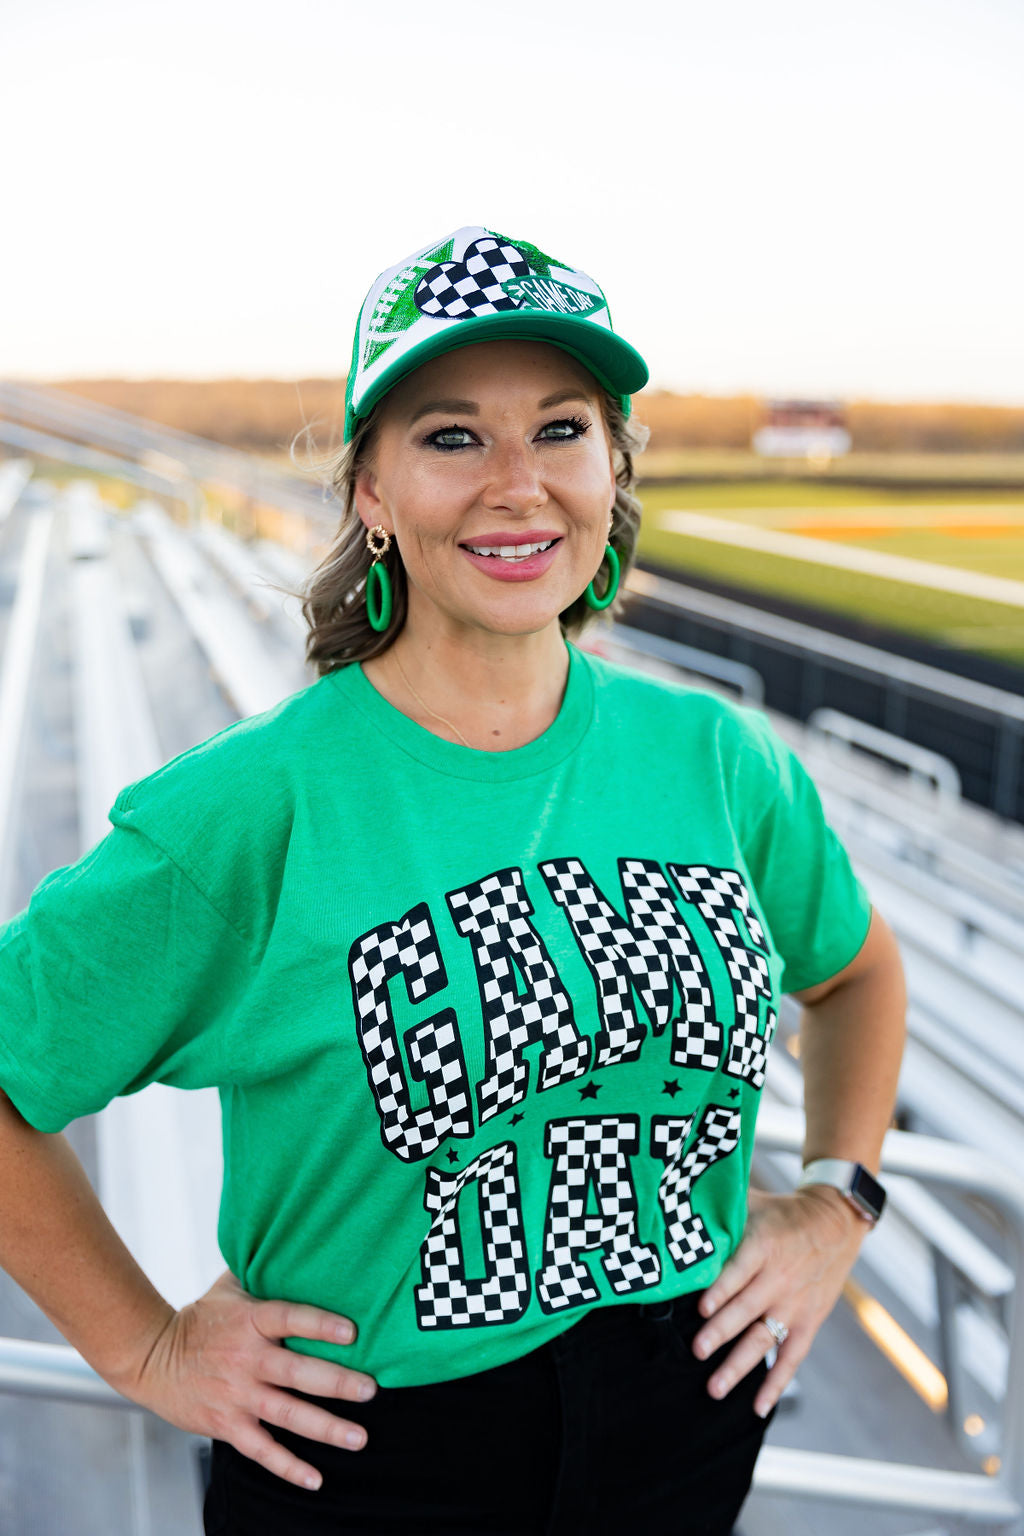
{"left": 0, "top": 1103, "right": 1024, "bottom": 1536}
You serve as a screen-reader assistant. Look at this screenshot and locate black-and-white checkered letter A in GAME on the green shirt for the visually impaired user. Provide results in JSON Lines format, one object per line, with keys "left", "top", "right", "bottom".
{"left": 447, "top": 869, "right": 590, "bottom": 1124}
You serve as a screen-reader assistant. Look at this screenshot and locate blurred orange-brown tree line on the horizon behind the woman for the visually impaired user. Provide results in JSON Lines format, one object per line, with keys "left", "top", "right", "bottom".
{"left": 55, "top": 379, "right": 1024, "bottom": 455}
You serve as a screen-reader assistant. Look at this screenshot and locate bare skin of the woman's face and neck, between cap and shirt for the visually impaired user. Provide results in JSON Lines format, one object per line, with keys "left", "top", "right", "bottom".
{"left": 343, "top": 341, "right": 634, "bottom": 746}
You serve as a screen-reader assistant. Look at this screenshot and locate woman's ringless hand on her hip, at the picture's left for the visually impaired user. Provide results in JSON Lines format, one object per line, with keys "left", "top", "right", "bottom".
{"left": 114, "top": 1270, "right": 376, "bottom": 1488}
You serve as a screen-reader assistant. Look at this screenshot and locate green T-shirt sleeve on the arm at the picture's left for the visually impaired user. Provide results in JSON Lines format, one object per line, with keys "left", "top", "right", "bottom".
{"left": 0, "top": 826, "right": 252, "bottom": 1132}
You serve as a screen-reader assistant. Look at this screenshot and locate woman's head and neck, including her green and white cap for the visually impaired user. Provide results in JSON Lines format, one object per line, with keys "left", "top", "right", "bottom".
{"left": 291, "top": 227, "right": 648, "bottom": 748}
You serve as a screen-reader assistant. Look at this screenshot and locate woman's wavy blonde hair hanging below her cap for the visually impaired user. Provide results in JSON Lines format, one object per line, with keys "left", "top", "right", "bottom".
{"left": 282, "top": 390, "right": 649, "bottom": 677}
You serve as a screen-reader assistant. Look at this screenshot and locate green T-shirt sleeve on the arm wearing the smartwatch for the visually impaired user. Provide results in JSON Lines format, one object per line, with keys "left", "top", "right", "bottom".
{"left": 737, "top": 708, "right": 870, "bottom": 992}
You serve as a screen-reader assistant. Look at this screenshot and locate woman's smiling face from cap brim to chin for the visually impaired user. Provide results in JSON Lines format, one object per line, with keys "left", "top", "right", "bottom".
{"left": 356, "top": 341, "right": 616, "bottom": 639}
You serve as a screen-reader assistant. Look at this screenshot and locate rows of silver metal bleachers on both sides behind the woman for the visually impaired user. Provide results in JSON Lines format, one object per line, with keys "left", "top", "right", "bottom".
{"left": 0, "top": 396, "right": 1024, "bottom": 1536}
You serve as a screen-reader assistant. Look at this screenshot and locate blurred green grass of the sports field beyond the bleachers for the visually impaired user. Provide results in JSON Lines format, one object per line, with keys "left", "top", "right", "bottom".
{"left": 639, "top": 481, "right": 1024, "bottom": 667}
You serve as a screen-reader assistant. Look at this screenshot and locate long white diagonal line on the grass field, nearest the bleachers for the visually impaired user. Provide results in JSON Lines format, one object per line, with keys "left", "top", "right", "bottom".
{"left": 657, "top": 511, "right": 1024, "bottom": 608}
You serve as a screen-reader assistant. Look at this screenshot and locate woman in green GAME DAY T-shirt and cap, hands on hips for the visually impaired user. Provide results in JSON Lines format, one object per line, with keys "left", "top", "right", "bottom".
{"left": 0, "top": 227, "right": 904, "bottom": 1536}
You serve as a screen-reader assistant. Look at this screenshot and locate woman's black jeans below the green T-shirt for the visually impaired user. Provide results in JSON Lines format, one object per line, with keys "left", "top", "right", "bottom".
{"left": 204, "top": 1292, "right": 774, "bottom": 1536}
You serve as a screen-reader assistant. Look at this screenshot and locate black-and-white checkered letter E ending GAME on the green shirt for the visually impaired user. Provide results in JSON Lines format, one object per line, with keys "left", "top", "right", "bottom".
{"left": 668, "top": 865, "right": 777, "bottom": 1087}
